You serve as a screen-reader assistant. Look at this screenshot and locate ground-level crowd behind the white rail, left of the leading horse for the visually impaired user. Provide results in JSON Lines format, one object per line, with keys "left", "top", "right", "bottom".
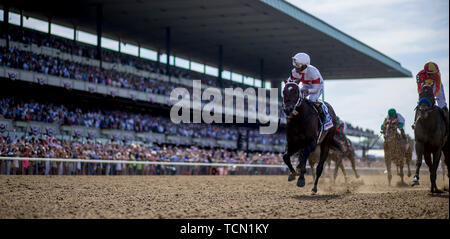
{"left": 0, "top": 135, "right": 282, "bottom": 175}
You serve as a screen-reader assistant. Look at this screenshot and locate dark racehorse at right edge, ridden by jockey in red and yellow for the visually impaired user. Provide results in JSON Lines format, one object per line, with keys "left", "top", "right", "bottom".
{"left": 411, "top": 85, "right": 449, "bottom": 193}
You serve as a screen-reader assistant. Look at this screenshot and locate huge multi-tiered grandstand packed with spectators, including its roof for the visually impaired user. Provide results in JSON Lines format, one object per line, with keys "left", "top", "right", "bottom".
{"left": 0, "top": 0, "right": 411, "bottom": 176}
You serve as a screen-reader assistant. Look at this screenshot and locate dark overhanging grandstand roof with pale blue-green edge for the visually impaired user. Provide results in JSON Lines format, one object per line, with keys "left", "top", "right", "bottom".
{"left": 6, "top": 0, "right": 411, "bottom": 83}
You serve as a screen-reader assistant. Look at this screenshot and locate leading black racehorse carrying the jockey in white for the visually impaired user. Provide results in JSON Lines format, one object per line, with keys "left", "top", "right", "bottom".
{"left": 283, "top": 82, "right": 342, "bottom": 194}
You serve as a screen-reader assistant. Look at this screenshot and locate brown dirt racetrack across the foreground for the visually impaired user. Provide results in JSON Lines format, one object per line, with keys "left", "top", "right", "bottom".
{"left": 0, "top": 173, "right": 449, "bottom": 219}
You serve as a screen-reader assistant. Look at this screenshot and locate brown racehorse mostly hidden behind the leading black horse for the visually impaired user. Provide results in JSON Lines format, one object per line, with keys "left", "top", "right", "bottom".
{"left": 308, "top": 136, "right": 359, "bottom": 183}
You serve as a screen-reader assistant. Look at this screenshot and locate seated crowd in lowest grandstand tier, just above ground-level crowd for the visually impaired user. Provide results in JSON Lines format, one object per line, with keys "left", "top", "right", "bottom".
{"left": 0, "top": 97, "right": 286, "bottom": 145}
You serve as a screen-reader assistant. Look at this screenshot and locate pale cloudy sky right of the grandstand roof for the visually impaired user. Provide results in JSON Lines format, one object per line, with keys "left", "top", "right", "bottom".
{"left": 287, "top": 0, "right": 449, "bottom": 137}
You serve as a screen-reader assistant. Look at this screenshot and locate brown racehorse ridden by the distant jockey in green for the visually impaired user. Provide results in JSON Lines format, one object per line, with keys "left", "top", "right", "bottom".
{"left": 383, "top": 119, "right": 411, "bottom": 185}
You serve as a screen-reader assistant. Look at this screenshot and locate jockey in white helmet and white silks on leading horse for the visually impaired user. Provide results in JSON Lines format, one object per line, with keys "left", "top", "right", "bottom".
{"left": 288, "top": 53, "right": 333, "bottom": 130}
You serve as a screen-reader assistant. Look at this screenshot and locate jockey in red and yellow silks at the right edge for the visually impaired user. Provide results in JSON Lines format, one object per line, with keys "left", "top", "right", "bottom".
{"left": 412, "top": 61, "right": 448, "bottom": 132}
